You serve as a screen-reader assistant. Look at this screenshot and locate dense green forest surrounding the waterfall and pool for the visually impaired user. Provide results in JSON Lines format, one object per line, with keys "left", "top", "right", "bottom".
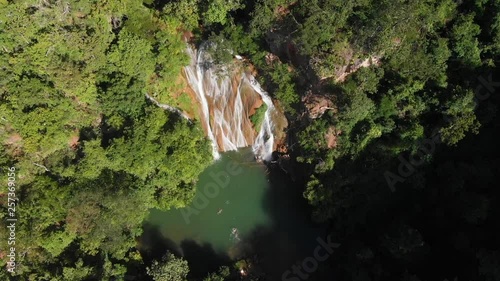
{"left": 0, "top": 0, "right": 500, "bottom": 281}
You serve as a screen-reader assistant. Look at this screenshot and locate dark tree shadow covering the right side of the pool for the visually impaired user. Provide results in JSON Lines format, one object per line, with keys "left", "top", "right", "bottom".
{"left": 237, "top": 167, "right": 326, "bottom": 280}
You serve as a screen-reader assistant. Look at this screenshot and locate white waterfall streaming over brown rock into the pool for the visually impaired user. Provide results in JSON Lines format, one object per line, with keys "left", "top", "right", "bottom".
{"left": 184, "top": 43, "right": 275, "bottom": 160}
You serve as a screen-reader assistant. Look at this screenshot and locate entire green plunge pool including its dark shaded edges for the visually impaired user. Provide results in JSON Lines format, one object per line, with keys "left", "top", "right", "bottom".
{"left": 139, "top": 149, "right": 324, "bottom": 280}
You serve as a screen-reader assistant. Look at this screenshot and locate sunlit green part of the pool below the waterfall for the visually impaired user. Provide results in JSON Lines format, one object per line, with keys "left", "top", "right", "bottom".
{"left": 148, "top": 150, "right": 271, "bottom": 256}
